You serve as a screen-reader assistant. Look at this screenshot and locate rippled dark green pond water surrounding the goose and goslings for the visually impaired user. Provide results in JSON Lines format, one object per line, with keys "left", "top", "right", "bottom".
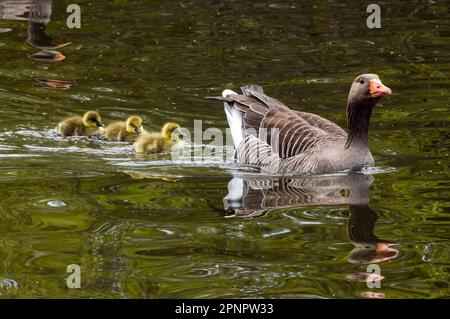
{"left": 0, "top": 0, "right": 450, "bottom": 298}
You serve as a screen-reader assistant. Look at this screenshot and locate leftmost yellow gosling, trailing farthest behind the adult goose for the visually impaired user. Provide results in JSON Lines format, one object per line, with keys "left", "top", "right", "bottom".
{"left": 56, "top": 111, "right": 105, "bottom": 136}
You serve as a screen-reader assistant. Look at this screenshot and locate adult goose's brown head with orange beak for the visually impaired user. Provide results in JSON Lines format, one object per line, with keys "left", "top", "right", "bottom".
{"left": 347, "top": 74, "right": 392, "bottom": 108}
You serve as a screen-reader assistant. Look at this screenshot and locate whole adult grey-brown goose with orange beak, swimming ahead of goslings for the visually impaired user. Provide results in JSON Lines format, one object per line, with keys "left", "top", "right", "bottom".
{"left": 208, "top": 74, "right": 391, "bottom": 174}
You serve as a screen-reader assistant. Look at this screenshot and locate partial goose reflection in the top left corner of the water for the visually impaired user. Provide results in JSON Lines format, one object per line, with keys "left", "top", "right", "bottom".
{"left": 0, "top": 0, "right": 70, "bottom": 62}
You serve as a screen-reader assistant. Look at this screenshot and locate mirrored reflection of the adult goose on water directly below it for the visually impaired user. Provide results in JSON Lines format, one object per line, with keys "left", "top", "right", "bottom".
{"left": 224, "top": 173, "right": 399, "bottom": 298}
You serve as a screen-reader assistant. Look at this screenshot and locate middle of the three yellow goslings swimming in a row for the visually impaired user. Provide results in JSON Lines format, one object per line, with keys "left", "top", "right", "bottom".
{"left": 105, "top": 115, "right": 143, "bottom": 142}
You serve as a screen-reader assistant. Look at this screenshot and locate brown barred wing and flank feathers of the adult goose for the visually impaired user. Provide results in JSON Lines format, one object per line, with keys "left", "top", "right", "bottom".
{"left": 218, "top": 88, "right": 347, "bottom": 173}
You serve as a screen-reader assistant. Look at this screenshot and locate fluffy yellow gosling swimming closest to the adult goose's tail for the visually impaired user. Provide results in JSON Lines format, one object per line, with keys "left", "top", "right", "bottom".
{"left": 133, "top": 122, "right": 183, "bottom": 153}
